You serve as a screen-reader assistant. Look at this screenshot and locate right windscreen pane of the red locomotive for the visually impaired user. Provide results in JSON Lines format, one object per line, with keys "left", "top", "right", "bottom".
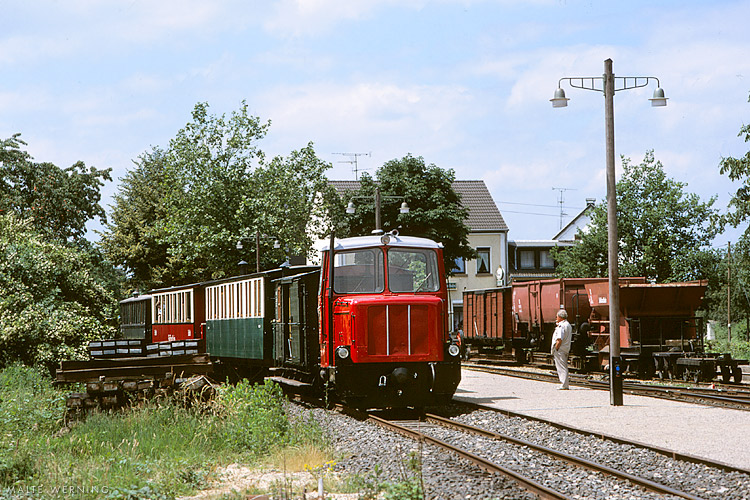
{"left": 388, "top": 249, "right": 440, "bottom": 292}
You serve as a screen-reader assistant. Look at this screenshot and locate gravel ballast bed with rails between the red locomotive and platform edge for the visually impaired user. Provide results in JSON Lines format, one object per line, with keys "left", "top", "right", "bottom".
{"left": 284, "top": 376, "right": 750, "bottom": 500}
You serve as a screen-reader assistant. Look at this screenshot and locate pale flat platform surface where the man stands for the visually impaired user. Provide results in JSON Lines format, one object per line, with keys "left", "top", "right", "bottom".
{"left": 456, "top": 370, "right": 750, "bottom": 474}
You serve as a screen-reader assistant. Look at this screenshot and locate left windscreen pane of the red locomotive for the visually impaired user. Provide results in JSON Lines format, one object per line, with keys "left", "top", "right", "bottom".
{"left": 333, "top": 248, "right": 385, "bottom": 293}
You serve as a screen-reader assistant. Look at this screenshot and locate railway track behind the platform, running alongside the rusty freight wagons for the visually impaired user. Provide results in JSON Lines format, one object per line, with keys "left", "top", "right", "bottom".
{"left": 462, "top": 364, "right": 750, "bottom": 411}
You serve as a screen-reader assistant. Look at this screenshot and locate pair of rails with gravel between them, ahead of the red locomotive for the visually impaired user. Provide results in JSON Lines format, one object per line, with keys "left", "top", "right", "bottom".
{"left": 369, "top": 414, "right": 701, "bottom": 499}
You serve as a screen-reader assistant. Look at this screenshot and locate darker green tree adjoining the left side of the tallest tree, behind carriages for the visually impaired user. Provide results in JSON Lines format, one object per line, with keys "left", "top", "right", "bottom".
{"left": 99, "top": 148, "right": 174, "bottom": 292}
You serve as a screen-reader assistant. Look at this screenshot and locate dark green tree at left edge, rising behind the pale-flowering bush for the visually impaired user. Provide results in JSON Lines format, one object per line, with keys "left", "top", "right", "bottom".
{"left": 0, "top": 134, "right": 112, "bottom": 240}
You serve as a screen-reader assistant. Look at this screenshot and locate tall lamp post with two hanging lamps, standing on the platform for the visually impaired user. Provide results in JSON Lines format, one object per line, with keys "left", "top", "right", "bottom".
{"left": 550, "top": 59, "right": 667, "bottom": 406}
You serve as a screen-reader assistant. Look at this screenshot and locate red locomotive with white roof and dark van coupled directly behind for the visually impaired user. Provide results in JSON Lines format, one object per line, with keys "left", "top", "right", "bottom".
{"left": 272, "top": 232, "right": 461, "bottom": 408}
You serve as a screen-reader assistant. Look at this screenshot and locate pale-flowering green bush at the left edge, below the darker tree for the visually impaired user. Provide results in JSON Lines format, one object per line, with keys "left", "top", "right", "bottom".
{"left": 0, "top": 214, "right": 116, "bottom": 368}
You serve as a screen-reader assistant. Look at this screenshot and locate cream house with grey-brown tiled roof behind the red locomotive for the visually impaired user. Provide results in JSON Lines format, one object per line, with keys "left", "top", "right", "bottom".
{"left": 329, "top": 180, "right": 509, "bottom": 330}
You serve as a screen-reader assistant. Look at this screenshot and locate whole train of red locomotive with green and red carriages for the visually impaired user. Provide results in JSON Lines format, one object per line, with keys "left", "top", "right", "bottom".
{"left": 63, "top": 232, "right": 461, "bottom": 408}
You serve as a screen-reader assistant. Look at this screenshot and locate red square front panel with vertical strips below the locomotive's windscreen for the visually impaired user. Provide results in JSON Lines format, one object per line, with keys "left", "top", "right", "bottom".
{"left": 367, "top": 304, "right": 430, "bottom": 356}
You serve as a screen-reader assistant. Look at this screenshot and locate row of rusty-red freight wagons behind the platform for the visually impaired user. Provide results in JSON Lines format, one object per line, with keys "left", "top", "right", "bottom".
{"left": 463, "top": 277, "right": 747, "bottom": 382}
